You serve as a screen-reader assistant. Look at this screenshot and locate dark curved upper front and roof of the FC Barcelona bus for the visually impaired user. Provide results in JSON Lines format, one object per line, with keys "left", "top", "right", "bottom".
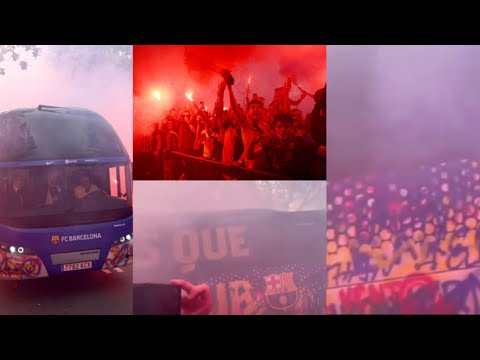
{"left": 0, "top": 105, "right": 128, "bottom": 162}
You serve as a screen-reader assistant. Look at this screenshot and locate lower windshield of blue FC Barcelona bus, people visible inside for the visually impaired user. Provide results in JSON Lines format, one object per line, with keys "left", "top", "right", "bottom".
{"left": 0, "top": 163, "right": 132, "bottom": 228}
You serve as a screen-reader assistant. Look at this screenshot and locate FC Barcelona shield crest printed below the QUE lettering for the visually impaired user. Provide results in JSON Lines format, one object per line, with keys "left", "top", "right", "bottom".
{"left": 263, "top": 272, "right": 299, "bottom": 310}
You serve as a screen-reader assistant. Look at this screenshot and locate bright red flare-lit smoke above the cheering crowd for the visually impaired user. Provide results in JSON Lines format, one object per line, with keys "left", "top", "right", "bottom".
{"left": 133, "top": 45, "right": 326, "bottom": 133}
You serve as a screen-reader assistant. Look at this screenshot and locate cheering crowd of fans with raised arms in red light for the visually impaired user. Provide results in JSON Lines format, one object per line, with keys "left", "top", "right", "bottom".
{"left": 137, "top": 71, "right": 326, "bottom": 180}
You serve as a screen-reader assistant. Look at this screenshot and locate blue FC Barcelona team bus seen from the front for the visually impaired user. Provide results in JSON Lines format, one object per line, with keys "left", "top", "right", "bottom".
{"left": 0, "top": 105, "right": 133, "bottom": 280}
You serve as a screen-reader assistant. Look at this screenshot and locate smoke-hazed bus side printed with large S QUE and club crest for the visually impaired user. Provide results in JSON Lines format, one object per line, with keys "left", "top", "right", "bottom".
{"left": 134, "top": 210, "right": 326, "bottom": 315}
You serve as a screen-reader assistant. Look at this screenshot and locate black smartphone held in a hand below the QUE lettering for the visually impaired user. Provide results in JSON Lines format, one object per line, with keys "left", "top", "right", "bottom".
{"left": 133, "top": 284, "right": 181, "bottom": 315}
